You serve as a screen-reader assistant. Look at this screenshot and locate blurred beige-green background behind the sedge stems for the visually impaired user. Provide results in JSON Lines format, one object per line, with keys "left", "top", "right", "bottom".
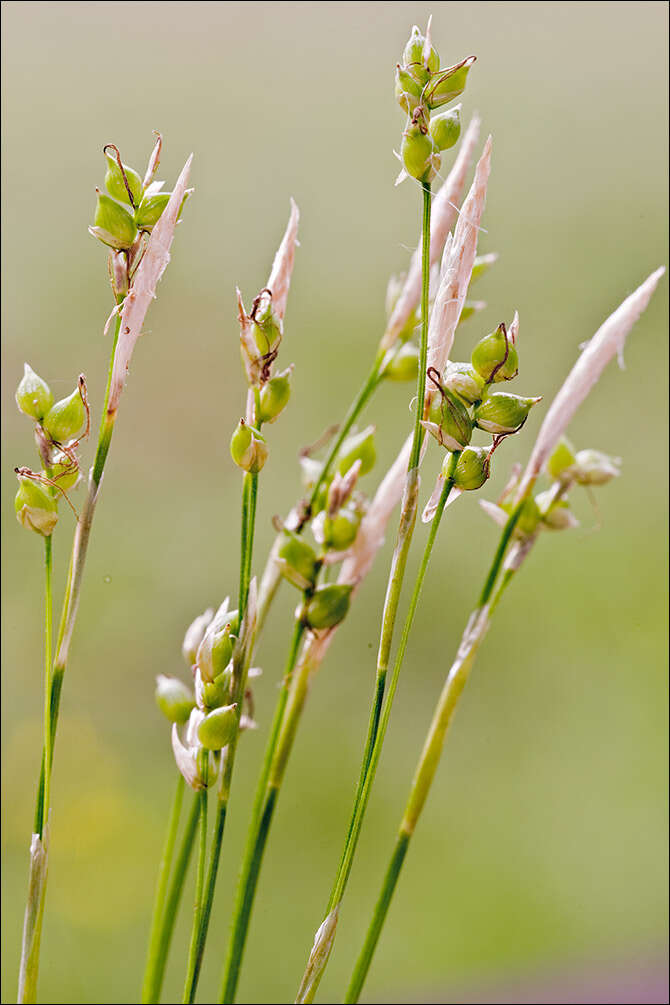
{"left": 2, "top": 2, "right": 667, "bottom": 1002}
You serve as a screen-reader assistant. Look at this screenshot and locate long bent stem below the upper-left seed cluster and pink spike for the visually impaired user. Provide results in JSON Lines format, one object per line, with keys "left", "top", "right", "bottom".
{"left": 18, "top": 298, "right": 123, "bottom": 1002}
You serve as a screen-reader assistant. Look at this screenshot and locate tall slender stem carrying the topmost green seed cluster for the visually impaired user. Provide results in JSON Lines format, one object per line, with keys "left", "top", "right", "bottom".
{"left": 296, "top": 183, "right": 431, "bottom": 1002}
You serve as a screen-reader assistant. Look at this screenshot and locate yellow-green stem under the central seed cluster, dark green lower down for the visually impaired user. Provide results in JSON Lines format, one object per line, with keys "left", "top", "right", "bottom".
{"left": 221, "top": 618, "right": 305, "bottom": 1001}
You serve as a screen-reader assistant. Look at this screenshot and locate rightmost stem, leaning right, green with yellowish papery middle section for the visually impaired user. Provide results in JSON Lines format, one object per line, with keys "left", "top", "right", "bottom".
{"left": 345, "top": 504, "right": 522, "bottom": 1005}
